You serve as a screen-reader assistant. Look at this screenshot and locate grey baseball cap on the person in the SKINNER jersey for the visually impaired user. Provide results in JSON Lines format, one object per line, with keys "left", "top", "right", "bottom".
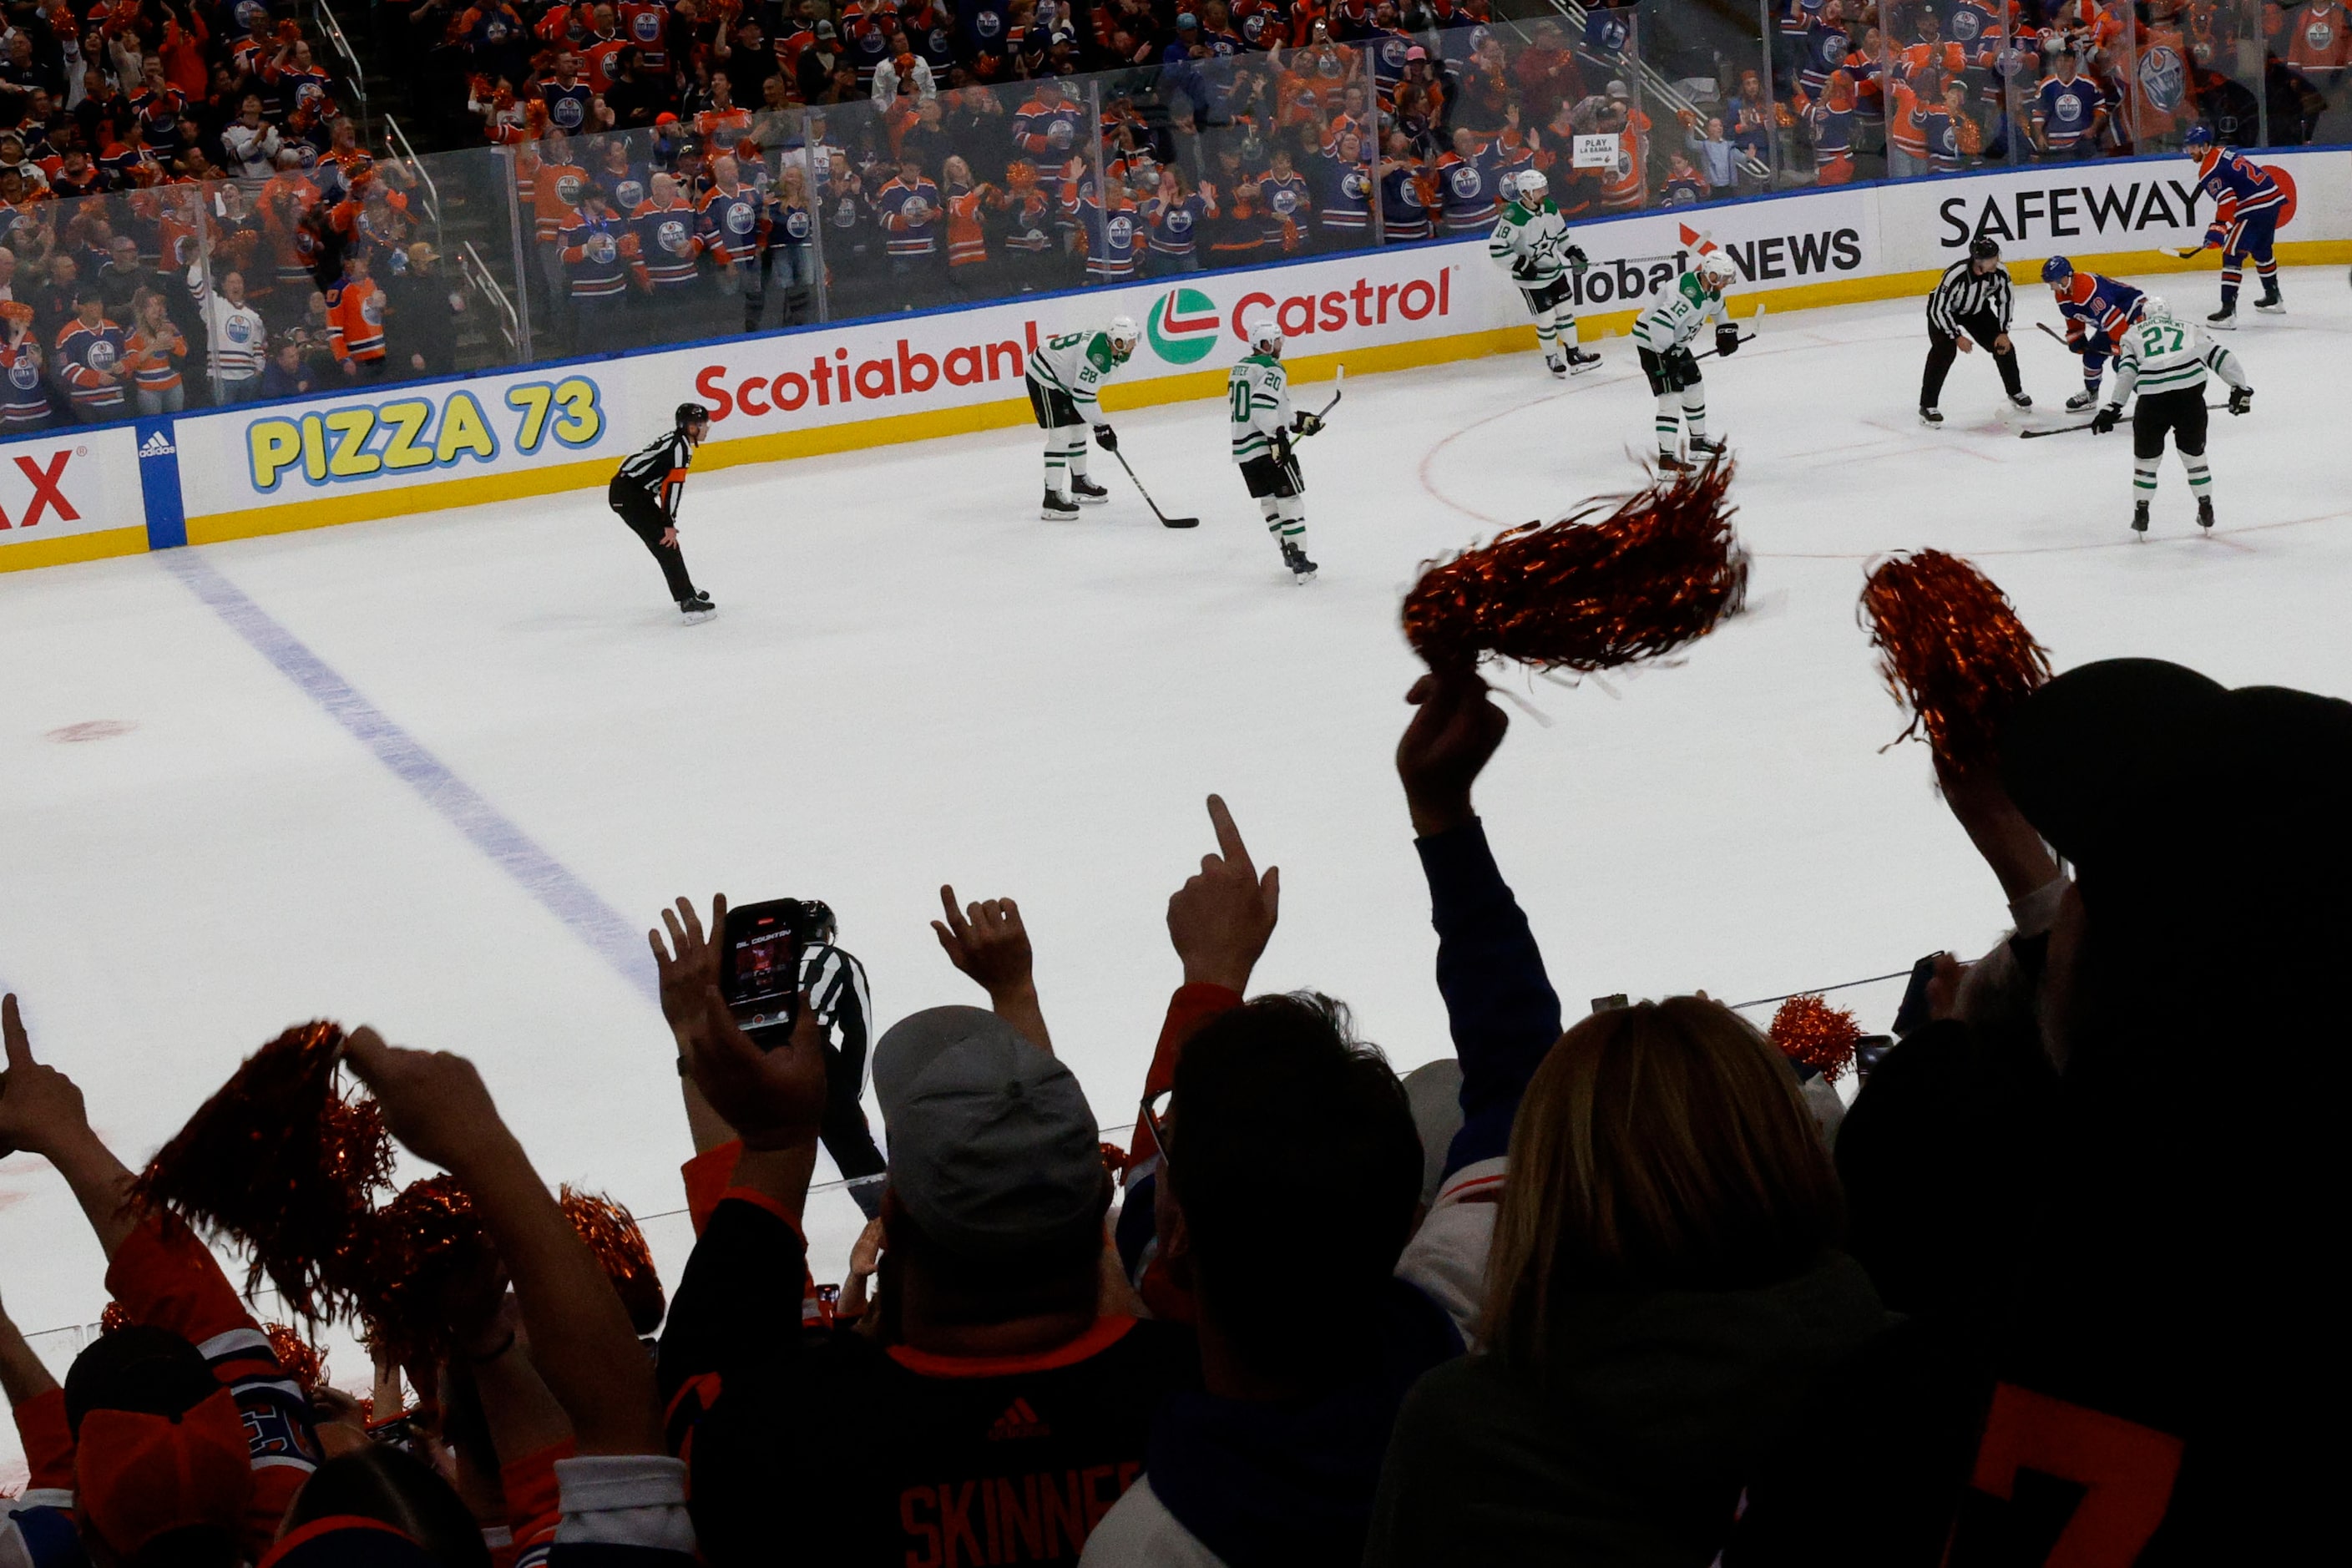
{"left": 875, "top": 1006, "right": 1108, "bottom": 1256}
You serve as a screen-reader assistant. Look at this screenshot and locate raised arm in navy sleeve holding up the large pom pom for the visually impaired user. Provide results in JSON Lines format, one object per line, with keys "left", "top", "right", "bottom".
{"left": 1397, "top": 670, "right": 1560, "bottom": 1176}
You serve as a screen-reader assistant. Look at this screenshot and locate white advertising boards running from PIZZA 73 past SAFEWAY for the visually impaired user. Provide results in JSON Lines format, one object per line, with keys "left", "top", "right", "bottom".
{"left": 147, "top": 150, "right": 2352, "bottom": 541}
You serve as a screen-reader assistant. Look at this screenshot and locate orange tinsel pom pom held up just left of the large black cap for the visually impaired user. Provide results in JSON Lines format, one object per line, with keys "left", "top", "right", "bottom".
{"left": 1863, "top": 550, "right": 2051, "bottom": 766}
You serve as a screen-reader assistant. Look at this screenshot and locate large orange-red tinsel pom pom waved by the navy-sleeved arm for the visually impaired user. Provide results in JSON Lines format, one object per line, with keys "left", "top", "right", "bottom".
{"left": 1404, "top": 463, "right": 1748, "bottom": 672}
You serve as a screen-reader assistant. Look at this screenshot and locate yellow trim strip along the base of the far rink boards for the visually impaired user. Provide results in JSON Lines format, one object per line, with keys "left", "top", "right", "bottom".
{"left": 179, "top": 240, "right": 2352, "bottom": 545}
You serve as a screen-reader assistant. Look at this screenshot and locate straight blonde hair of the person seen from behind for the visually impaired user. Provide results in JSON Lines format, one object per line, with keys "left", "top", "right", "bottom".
{"left": 1485, "top": 997, "right": 1844, "bottom": 1378}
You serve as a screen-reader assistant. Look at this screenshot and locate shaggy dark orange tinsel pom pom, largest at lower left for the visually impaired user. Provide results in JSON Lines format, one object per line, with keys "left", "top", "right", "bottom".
{"left": 132, "top": 1023, "right": 392, "bottom": 1321}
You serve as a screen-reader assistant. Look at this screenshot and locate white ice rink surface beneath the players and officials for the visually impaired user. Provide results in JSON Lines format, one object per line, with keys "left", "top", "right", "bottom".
{"left": 0, "top": 268, "right": 2352, "bottom": 1457}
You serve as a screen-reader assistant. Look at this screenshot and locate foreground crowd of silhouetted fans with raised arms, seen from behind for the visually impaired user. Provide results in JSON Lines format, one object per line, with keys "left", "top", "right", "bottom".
{"left": 0, "top": 644, "right": 2352, "bottom": 1568}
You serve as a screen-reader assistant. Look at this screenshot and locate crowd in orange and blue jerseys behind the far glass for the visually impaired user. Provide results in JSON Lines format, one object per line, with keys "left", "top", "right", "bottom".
{"left": 0, "top": 0, "right": 2352, "bottom": 411}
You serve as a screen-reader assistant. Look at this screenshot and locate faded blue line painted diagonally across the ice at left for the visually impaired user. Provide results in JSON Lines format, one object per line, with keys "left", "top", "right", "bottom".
{"left": 155, "top": 550, "right": 661, "bottom": 1006}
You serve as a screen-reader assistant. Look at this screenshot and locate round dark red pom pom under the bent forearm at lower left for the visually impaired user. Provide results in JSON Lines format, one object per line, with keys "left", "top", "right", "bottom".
{"left": 353, "top": 1176, "right": 503, "bottom": 1368}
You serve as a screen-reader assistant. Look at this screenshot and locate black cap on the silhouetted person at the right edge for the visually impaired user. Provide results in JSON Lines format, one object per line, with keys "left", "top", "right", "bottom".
{"left": 2001, "top": 658, "right": 2352, "bottom": 905}
